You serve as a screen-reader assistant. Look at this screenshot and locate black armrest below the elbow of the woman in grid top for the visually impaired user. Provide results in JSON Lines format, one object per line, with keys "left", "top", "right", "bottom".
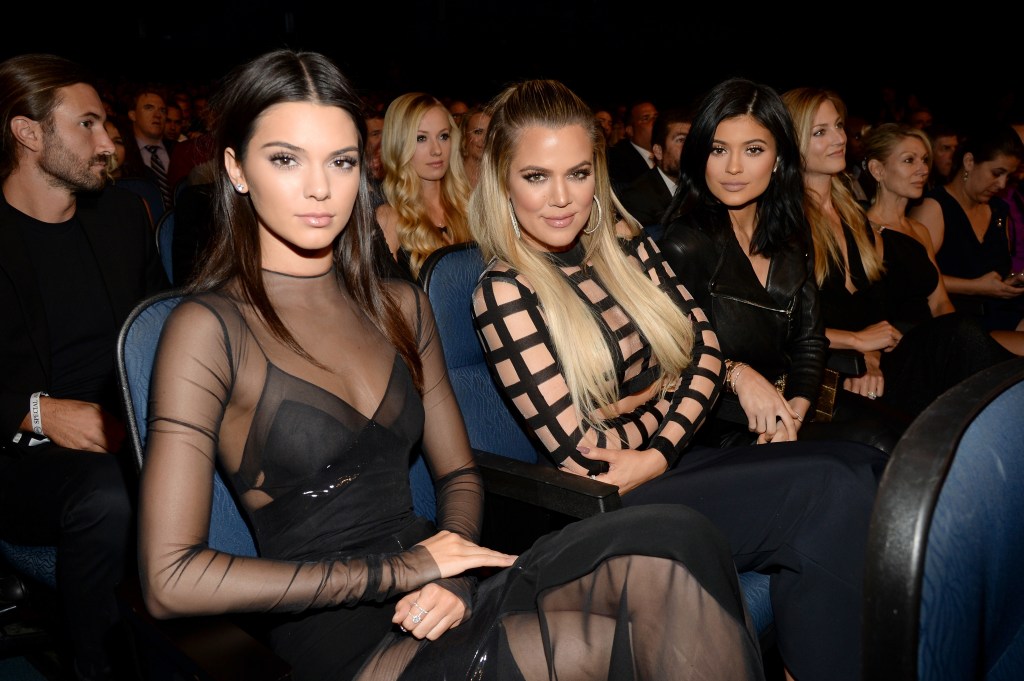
{"left": 473, "top": 450, "right": 623, "bottom": 518}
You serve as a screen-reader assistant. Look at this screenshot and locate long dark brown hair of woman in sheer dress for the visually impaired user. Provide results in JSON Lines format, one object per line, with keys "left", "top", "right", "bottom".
{"left": 188, "top": 49, "right": 423, "bottom": 390}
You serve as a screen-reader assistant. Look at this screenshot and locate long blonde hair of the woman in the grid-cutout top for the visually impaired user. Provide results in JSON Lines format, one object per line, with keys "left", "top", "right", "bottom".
{"left": 469, "top": 80, "right": 693, "bottom": 429}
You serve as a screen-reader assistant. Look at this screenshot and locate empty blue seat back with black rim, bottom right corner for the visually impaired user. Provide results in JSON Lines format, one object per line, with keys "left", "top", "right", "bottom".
{"left": 863, "top": 358, "right": 1024, "bottom": 681}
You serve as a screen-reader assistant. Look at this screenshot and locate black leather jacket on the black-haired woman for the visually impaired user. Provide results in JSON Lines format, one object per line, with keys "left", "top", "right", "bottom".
{"left": 658, "top": 218, "right": 828, "bottom": 405}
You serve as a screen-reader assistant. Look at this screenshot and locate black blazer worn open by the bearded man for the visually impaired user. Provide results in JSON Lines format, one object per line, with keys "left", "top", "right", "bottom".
{"left": 0, "top": 186, "right": 170, "bottom": 432}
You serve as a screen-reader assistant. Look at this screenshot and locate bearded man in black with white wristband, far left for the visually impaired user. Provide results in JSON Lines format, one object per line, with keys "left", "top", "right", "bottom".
{"left": 0, "top": 54, "right": 168, "bottom": 679}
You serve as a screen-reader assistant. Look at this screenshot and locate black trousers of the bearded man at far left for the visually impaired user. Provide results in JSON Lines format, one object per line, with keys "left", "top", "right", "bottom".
{"left": 0, "top": 437, "right": 135, "bottom": 679}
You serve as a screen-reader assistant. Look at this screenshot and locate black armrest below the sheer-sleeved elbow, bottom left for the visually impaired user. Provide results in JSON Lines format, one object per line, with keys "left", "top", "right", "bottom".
{"left": 118, "top": 580, "right": 292, "bottom": 681}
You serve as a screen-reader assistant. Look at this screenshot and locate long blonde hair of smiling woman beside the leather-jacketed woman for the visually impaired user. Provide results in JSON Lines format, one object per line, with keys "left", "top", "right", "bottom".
{"left": 782, "top": 87, "right": 885, "bottom": 286}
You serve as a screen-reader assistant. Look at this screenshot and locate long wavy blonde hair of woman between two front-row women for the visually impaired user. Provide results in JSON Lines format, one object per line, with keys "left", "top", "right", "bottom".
{"left": 381, "top": 92, "right": 471, "bottom": 276}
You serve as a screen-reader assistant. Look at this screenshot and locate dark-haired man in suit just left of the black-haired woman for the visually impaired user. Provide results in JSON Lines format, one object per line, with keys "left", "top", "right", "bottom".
{"left": 618, "top": 109, "right": 692, "bottom": 228}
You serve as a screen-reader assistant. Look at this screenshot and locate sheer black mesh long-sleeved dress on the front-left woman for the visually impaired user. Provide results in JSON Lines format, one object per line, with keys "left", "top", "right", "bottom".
{"left": 140, "top": 272, "right": 762, "bottom": 681}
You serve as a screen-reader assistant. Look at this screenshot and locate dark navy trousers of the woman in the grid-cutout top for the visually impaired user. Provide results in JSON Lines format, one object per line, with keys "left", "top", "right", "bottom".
{"left": 623, "top": 441, "right": 887, "bottom": 681}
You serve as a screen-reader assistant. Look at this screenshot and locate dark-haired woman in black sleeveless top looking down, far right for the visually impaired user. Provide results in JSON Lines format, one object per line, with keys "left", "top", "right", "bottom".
{"left": 909, "top": 122, "right": 1024, "bottom": 331}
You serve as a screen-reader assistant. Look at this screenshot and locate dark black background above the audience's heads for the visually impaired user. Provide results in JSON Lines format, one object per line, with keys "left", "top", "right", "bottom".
{"left": 0, "top": 0, "right": 1024, "bottom": 124}
